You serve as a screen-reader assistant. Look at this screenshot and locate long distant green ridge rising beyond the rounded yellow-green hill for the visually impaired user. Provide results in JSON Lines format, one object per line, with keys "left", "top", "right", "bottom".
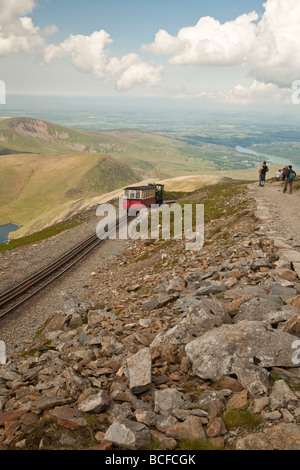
{"left": 0, "top": 118, "right": 250, "bottom": 178}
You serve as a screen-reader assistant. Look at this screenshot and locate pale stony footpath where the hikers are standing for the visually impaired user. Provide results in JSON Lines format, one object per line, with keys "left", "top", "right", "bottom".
{"left": 249, "top": 182, "right": 300, "bottom": 251}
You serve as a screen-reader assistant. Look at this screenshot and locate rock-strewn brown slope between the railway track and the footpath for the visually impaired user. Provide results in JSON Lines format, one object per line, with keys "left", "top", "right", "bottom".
{"left": 0, "top": 184, "right": 300, "bottom": 450}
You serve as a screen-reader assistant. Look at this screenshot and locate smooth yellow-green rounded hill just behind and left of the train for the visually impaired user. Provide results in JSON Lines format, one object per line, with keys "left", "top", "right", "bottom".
{"left": 0, "top": 153, "right": 136, "bottom": 236}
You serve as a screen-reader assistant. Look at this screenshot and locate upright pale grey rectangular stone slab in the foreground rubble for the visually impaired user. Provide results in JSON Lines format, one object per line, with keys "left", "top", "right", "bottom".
{"left": 127, "top": 348, "right": 152, "bottom": 394}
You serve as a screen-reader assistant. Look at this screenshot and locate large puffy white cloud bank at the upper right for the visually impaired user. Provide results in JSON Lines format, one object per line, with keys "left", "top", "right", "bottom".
{"left": 142, "top": 0, "right": 300, "bottom": 87}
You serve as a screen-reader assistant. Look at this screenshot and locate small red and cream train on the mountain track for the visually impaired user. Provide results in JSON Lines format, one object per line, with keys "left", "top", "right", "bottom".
{"left": 123, "top": 183, "right": 165, "bottom": 211}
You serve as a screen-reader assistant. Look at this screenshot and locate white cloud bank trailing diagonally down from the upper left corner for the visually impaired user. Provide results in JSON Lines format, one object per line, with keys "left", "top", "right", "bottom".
{"left": 0, "top": 0, "right": 161, "bottom": 90}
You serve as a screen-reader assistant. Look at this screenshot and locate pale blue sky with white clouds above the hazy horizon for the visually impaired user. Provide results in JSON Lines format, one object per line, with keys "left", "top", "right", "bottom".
{"left": 0, "top": 0, "right": 300, "bottom": 107}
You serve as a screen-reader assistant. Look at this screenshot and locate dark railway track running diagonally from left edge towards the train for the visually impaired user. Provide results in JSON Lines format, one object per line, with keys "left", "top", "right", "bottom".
{"left": 0, "top": 219, "right": 125, "bottom": 318}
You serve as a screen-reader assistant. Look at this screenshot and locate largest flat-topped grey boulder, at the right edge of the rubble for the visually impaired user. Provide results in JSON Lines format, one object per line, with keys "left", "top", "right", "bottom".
{"left": 185, "top": 321, "right": 298, "bottom": 391}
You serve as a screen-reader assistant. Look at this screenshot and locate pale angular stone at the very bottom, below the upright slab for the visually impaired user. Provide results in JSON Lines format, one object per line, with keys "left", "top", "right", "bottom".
{"left": 104, "top": 418, "right": 151, "bottom": 450}
